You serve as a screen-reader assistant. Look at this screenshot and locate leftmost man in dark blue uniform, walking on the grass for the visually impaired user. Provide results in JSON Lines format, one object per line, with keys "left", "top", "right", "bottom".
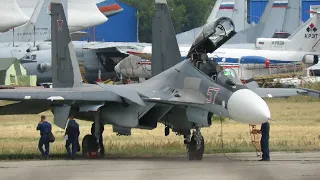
{"left": 37, "top": 115, "right": 52, "bottom": 159}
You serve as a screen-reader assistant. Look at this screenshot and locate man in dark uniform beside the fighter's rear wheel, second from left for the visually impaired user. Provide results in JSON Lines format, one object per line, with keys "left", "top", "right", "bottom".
{"left": 65, "top": 115, "right": 80, "bottom": 159}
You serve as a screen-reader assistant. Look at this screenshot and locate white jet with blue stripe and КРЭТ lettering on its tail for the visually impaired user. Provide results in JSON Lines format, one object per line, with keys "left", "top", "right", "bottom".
{"left": 115, "top": 13, "right": 320, "bottom": 79}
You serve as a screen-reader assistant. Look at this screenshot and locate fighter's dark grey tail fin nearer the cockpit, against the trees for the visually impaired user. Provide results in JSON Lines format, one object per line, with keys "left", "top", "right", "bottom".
{"left": 151, "top": 0, "right": 181, "bottom": 76}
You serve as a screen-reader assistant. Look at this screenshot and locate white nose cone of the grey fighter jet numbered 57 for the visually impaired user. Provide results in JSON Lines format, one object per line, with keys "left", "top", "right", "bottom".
{"left": 228, "top": 89, "right": 271, "bottom": 124}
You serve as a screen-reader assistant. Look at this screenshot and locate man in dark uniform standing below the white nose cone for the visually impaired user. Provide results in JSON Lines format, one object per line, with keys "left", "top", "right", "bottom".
{"left": 260, "top": 122, "right": 270, "bottom": 161}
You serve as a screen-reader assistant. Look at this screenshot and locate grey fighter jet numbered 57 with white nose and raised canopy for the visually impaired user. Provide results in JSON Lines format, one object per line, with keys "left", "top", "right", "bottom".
{"left": 0, "top": 0, "right": 319, "bottom": 160}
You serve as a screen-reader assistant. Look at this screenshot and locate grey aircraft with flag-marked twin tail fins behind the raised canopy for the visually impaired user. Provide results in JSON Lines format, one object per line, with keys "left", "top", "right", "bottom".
{"left": 177, "top": 0, "right": 303, "bottom": 44}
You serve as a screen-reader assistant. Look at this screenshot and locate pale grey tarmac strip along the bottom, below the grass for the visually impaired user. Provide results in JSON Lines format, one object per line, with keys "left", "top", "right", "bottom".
{"left": 0, "top": 152, "right": 320, "bottom": 180}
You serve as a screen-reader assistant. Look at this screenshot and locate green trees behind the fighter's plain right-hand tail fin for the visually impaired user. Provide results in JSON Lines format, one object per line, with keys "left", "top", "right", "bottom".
{"left": 121, "top": 0, "right": 215, "bottom": 42}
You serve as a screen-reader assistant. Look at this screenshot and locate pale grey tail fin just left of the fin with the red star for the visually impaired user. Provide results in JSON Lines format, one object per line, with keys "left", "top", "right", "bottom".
{"left": 0, "top": 0, "right": 51, "bottom": 43}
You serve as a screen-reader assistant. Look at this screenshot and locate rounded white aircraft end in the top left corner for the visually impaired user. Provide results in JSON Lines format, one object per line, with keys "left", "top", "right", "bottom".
{"left": 0, "top": 0, "right": 30, "bottom": 32}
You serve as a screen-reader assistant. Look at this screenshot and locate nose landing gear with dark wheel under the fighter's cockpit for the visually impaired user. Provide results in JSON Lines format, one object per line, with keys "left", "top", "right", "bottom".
{"left": 184, "top": 126, "right": 204, "bottom": 160}
